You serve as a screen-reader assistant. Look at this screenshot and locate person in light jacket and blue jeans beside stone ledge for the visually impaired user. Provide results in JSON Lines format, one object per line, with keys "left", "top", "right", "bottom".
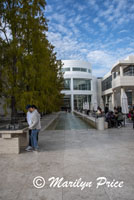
{"left": 29, "top": 105, "right": 41, "bottom": 151}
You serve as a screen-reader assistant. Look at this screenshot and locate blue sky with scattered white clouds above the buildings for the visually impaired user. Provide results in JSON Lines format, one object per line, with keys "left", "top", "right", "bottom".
{"left": 45, "top": 0, "right": 134, "bottom": 77}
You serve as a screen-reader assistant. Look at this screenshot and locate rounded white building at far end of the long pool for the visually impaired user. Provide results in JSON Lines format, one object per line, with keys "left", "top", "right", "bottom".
{"left": 62, "top": 60, "right": 96, "bottom": 111}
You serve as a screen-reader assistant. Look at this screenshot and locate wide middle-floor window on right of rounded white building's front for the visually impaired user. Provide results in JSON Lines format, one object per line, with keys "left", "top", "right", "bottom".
{"left": 73, "top": 79, "right": 91, "bottom": 90}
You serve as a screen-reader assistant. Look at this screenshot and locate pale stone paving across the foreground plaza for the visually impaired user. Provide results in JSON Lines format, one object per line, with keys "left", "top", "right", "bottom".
{"left": 0, "top": 114, "right": 134, "bottom": 200}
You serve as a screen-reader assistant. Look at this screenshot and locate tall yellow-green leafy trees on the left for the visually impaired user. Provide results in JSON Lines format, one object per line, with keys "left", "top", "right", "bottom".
{"left": 0, "top": 0, "right": 63, "bottom": 117}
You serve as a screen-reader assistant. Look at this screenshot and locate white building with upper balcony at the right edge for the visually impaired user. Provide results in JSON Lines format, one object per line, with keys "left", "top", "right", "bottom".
{"left": 102, "top": 56, "right": 134, "bottom": 107}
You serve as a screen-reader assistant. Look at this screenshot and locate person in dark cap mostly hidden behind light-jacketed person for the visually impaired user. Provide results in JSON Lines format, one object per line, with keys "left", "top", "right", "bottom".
{"left": 25, "top": 105, "right": 32, "bottom": 151}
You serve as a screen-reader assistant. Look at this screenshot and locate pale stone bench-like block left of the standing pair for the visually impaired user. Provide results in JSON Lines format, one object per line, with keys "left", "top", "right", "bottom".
{"left": 0, "top": 128, "right": 29, "bottom": 154}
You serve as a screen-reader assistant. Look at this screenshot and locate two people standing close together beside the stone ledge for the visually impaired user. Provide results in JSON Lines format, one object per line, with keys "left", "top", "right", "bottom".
{"left": 25, "top": 105, "right": 41, "bottom": 151}
